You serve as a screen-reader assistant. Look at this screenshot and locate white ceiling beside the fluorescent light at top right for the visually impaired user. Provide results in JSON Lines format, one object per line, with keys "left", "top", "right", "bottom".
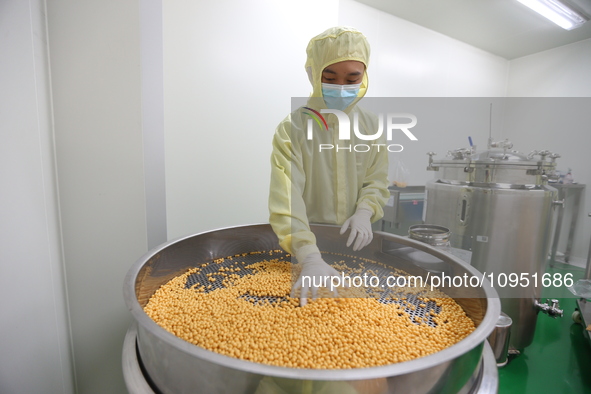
{"left": 357, "top": 0, "right": 591, "bottom": 59}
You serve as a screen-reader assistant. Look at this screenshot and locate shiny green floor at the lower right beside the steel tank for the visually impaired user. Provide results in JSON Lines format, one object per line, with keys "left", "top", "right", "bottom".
{"left": 499, "top": 263, "right": 591, "bottom": 394}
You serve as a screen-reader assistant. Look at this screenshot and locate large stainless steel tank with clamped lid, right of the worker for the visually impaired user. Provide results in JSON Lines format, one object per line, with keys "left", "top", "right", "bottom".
{"left": 424, "top": 140, "right": 560, "bottom": 350}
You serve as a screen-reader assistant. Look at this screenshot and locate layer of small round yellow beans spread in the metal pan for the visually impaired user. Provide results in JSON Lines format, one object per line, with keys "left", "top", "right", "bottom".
{"left": 144, "top": 254, "right": 475, "bottom": 369}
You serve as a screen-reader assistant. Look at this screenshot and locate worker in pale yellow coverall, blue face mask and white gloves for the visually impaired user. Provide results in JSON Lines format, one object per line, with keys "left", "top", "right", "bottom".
{"left": 269, "top": 27, "right": 390, "bottom": 306}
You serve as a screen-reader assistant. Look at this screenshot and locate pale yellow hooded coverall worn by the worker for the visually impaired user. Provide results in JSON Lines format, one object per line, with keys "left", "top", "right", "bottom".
{"left": 269, "top": 27, "right": 390, "bottom": 261}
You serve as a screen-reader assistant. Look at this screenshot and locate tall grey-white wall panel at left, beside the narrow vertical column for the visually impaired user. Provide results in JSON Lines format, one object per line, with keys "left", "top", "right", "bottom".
{"left": 47, "top": 0, "right": 147, "bottom": 394}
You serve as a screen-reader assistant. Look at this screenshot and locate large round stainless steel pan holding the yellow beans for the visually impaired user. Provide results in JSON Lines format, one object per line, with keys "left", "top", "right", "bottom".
{"left": 124, "top": 224, "right": 500, "bottom": 393}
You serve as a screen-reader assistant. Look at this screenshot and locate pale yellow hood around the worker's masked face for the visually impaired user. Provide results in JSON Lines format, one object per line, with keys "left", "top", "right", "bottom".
{"left": 306, "top": 26, "right": 370, "bottom": 108}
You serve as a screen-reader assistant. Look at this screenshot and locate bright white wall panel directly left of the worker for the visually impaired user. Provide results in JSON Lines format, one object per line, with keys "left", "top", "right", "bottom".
{"left": 163, "top": 0, "right": 338, "bottom": 239}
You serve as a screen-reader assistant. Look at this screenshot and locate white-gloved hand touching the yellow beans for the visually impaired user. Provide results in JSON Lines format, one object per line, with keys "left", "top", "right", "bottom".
{"left": 291, "top": 253, "right": 341, "bottom": 306}
